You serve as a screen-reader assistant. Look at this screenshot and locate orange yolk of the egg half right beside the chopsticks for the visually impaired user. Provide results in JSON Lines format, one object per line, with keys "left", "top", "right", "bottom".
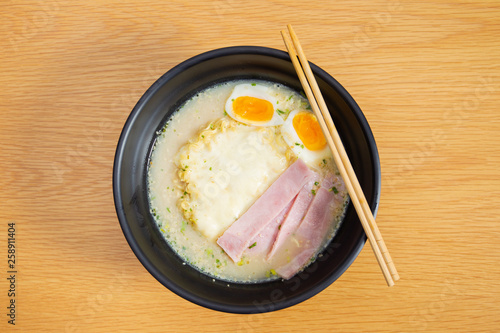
{"left": 292, "top": 112, "right": 326, "bottom": 150}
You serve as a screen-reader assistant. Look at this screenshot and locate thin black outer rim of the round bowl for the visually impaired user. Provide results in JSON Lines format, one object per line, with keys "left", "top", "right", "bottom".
{"left": 112, "top": 45, "right": 381, "bottom": 314}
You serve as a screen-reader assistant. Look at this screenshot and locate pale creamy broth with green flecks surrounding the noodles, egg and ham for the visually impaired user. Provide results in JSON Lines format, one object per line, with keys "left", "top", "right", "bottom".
{"left": 147, "top": 80, "right": 348, "bottom": 282}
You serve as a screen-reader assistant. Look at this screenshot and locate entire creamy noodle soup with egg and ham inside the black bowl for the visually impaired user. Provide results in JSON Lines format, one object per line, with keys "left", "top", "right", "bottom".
{"left": 147, "top": 80, "right": 348, "bottom": 282}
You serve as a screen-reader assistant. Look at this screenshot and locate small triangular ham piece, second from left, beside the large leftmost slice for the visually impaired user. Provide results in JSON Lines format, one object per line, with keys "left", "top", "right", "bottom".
{"left": 243, "top": 199, "right": 296, "bottom": 257}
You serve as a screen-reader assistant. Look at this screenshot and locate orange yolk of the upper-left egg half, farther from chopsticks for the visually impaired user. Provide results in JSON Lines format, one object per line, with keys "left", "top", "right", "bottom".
{"left": 233, "top": 96, "right": 274, "bottom": 122}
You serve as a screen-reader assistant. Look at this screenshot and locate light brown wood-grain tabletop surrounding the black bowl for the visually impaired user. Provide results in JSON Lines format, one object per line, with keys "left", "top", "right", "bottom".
{"left": 0, "top": 0, "right": 500, "bottom": 332}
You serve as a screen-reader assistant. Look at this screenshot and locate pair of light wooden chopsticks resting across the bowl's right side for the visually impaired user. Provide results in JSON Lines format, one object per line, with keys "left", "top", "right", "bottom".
{"left": 281, "top": 25, "right": 399, "bottom": 286}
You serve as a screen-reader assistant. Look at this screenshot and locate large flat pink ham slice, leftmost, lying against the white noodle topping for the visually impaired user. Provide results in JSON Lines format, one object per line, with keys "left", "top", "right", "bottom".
{"left": 217, "top": 159, "right": 314, "bottom": 262}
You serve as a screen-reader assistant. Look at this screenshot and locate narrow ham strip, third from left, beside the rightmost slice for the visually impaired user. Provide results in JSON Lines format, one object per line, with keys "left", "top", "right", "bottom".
{"left": 267, "top": 173, "right": 320, "bottom": 260}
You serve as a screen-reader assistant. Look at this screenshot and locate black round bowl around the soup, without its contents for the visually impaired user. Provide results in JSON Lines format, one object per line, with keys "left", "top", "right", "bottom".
{"left": 113, "top": 46, "right": 380, "bottom": 313}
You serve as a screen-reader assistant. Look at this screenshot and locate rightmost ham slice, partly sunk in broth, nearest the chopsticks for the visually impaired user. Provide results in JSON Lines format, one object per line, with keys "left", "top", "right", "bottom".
{"left": 275, "top": 188, "right": 335, "bottom": 279}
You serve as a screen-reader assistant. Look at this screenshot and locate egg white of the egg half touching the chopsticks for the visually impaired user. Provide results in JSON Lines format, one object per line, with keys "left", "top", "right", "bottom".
{"left": 281, "top": 110, "right": 333, "bottom": 168}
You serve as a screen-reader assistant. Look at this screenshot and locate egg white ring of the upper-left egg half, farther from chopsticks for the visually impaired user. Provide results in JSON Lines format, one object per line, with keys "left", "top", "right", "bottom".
{"left": 225, "top": 83, "right": 284, "bottom": 126}
